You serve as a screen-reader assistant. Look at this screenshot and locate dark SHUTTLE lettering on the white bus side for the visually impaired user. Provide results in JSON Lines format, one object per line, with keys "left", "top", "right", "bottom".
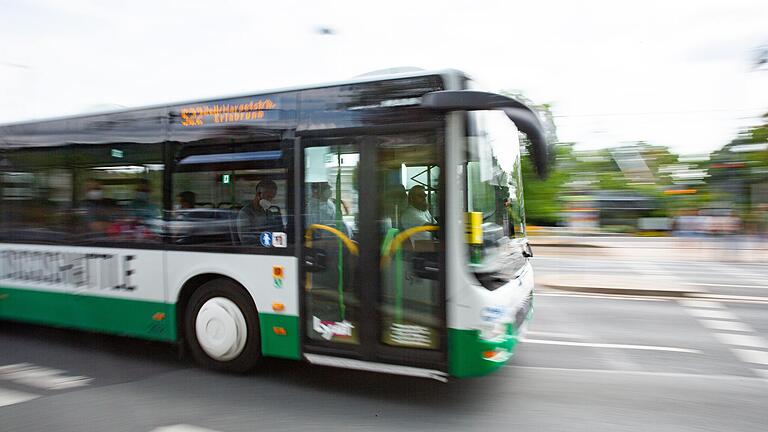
{"left": 0, "top": 250, "right": 136, "bottom": 291}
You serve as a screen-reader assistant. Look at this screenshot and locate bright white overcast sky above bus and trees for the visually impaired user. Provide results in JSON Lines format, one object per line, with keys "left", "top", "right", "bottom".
{"left": 0, "top": 0, "right": 768, "bottom": 153}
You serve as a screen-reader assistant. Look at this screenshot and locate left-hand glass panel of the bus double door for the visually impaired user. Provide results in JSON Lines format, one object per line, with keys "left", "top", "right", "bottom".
{"left": 303, "top": 144, "right": 361, "bottom": 344}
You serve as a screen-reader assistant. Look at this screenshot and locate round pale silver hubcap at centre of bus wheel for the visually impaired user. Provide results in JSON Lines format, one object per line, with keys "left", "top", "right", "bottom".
{"left": 195, "top": 297, "right": 248, "bottom": 361}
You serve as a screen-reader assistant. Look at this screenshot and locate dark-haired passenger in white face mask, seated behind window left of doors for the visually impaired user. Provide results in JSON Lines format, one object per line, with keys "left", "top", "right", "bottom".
{"left": 237, "top": 180, "right": 285, "bottom": 245}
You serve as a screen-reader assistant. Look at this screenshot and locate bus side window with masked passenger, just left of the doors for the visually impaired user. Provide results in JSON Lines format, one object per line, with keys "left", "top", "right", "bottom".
{"left": 171, "top": 142, "right": 293, "bottom": 249}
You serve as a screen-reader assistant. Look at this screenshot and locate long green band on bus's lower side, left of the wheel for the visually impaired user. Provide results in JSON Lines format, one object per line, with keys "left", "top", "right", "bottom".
{"left": 0, "top": 287, "right": 176, "bottom": 341}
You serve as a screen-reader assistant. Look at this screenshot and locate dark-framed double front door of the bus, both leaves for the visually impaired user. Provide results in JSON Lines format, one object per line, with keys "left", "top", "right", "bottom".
{"left": 300, "top": 131, "right": 446, "bottom": 369}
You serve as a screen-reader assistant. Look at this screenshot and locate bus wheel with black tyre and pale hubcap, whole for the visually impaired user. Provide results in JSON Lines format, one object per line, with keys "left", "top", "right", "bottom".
{"left": 184, "top": 279, "right": 261, "bottom": 373}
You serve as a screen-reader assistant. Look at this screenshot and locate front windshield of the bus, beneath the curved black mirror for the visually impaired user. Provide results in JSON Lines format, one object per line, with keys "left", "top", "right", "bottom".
{"left": 466, "top": 111, "right": 525, "bottom": 281}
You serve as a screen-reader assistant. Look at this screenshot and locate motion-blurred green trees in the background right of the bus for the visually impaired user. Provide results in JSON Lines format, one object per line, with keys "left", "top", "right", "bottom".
{"left": 502, "top": 91, "right": 768, "bottom": 230}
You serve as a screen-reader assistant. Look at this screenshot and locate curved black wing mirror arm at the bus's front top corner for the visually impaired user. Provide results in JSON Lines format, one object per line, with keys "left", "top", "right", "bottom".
{"left": 421, "top": 90, "right": 554, "bottom": 178}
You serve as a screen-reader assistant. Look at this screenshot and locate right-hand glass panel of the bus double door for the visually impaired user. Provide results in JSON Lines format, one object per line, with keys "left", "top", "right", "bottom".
{"left": 378, "top": 133, "right": 444, "bottom": 349}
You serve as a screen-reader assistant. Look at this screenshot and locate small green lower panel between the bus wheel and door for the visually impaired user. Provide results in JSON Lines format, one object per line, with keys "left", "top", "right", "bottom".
{"left": 259, "top": 313, "right": 301, "bottom": 360}
